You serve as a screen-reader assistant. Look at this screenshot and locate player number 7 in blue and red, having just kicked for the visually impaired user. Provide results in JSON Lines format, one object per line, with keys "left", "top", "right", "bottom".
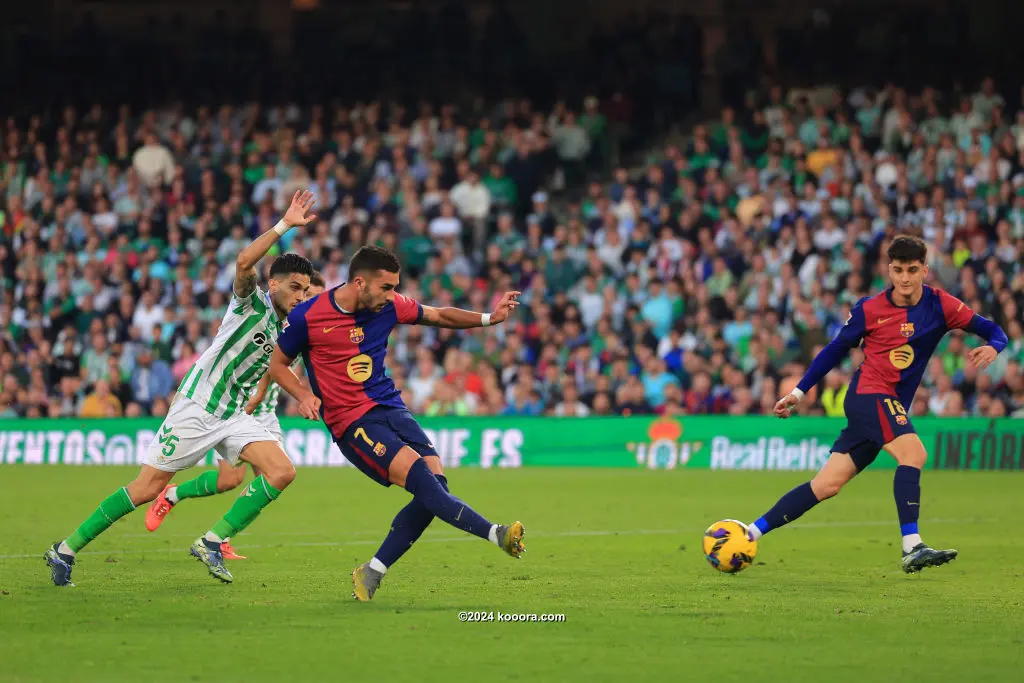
{"left": 269, "top": 247, "right": 525, "bottom": 601}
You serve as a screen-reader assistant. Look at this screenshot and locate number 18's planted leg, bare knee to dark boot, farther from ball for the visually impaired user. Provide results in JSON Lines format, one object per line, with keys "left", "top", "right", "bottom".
{"left": 883, "top": 433, "right": 957, "bottom": 573}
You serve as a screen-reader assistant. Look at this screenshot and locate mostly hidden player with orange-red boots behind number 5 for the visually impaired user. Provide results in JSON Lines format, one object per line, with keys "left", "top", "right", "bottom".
{"left": 145, "top": 270, "right": 327, "bottom": 560}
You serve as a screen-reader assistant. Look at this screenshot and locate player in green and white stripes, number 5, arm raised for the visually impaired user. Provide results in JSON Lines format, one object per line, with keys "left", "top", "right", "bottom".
{"left": 44, "top": 190, "right": 316, "bottom": 586}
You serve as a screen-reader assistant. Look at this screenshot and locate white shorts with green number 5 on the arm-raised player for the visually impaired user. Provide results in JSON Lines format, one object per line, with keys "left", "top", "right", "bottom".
{"left": 145, "top": 396, "right": 278, "bottom": 472}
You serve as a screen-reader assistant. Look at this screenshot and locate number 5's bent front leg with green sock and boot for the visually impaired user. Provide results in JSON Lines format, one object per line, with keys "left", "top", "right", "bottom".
{"left": 190, "top": 444, "right": 295, "bottom": 584}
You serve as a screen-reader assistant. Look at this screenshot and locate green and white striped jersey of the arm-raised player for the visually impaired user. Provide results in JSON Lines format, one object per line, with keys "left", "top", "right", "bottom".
{"left": 178, "top": 287, "right": 283, "bottom": 420}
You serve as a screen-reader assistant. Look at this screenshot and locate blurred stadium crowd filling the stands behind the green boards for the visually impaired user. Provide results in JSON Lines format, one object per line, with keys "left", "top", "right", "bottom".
{"left": 0, "top": 80, "right": 1024, "bottom": 418}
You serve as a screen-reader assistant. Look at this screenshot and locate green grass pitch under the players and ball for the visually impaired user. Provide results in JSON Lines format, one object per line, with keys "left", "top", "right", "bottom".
{"left": 0, "top": 466, "right": 1024, "bottom": 683}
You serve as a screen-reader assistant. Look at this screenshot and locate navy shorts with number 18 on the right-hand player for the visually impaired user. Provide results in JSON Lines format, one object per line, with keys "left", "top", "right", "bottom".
{"left": 831, "top": 386, "right": 914, "bottom": 472}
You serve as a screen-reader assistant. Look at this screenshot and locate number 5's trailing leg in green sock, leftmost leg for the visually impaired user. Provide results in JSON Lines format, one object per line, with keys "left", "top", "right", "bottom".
{"left": 43, "top": 465, "right": 174, "bottom": 586}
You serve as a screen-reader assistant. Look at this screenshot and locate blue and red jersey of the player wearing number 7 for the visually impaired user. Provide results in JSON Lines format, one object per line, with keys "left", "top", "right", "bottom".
{"left": 278, "top": 287, "right": 423, "bottom": 438}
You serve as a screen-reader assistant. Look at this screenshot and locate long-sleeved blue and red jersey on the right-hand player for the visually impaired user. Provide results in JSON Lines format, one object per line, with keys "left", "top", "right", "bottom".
{"left": 798, "top": 286, "right": 987, "bottom": 407}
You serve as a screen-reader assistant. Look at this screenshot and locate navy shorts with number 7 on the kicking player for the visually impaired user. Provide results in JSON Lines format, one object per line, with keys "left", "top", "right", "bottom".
{"left": 335, "top": 405, "right": 437, "bottom": 486}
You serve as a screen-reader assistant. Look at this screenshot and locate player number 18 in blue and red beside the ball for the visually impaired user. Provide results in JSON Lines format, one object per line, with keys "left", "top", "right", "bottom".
{"left": 748, "top": 236, "right": 1008, "bottom": 573}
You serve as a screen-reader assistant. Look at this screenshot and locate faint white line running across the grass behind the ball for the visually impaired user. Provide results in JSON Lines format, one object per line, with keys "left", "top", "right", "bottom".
{"left": 0, "top": 519, "right": 978, "bottom": 560}
